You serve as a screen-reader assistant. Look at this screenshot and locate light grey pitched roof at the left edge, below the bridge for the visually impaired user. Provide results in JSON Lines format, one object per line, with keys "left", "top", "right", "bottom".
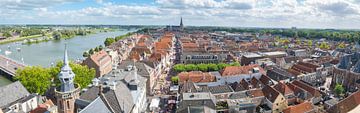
{"left": 0, "top": 81, "right": 30, "bottom": 108}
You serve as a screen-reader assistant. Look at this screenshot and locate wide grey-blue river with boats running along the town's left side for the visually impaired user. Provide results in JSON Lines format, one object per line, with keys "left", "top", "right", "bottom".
{"left": 0, "top": 30, "right": 135, "bottom": 86}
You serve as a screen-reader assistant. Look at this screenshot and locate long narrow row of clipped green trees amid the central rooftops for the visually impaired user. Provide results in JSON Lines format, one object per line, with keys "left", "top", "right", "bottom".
{"left": 173, "top": 62, "right": 240, "bottom": 72}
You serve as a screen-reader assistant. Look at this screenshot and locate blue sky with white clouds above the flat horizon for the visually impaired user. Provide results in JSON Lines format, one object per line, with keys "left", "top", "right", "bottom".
{"left": 0, "top": 0, "right": 360, "bottom": 29}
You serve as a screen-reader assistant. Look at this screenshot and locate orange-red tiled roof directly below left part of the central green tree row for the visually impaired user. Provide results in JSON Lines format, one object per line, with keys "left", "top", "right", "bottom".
{"left": 178, "top": 71, "right": 216, "bottom": 83}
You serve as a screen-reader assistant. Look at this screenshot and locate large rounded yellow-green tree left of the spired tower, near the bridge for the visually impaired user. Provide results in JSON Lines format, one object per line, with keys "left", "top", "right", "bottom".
{"left": 15, "top": 66, "right": 52, "bottom": 95}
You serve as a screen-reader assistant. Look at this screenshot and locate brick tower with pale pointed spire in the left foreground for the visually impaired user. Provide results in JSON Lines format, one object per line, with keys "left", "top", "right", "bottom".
{"left": 55, "top": 45, "right": 80, "bottom": 113}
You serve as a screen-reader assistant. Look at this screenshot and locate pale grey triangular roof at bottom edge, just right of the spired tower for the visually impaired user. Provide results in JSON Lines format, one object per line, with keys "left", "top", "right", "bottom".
{"left": 80, "top": 97, "right": 111, "bottom": 113}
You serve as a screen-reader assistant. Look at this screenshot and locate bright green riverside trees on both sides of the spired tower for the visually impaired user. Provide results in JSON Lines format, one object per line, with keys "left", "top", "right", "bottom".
{"left": 15, "top": 62, "right": 95, "bottom": 95}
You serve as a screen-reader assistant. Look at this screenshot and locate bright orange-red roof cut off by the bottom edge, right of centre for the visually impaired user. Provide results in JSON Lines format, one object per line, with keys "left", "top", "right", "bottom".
{"left": 283, "top": 102, "right": 314, "bottom": 113}
